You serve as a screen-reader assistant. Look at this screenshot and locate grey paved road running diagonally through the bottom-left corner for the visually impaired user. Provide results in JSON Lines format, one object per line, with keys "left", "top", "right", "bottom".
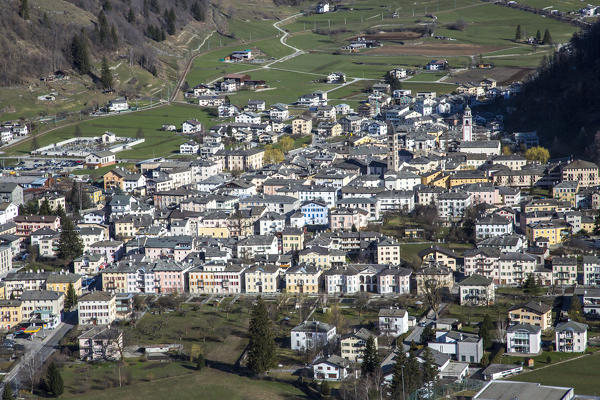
{"left": 2, "top": 322, "right": 73, "bottom": 388}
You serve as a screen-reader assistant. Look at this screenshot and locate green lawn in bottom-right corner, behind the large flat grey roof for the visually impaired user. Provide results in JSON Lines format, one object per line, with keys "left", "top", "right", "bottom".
{"left": 510, "top": 354, "right": 600, "bottom": 396}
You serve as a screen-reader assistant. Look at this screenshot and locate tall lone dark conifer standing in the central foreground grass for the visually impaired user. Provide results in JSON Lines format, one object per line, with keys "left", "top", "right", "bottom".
{"left": 248, "top": 298, "right": 275, "bottom": 374}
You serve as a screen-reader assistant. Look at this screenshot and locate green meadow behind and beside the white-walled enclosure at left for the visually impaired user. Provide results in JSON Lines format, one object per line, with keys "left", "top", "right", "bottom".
{"left": 5, "top": 104, "right": 212, "bottom": 160}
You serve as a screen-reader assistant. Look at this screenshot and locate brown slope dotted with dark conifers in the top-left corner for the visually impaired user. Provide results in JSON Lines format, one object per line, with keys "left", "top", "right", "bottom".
{"left": 0, "top": 0, "right": 211, "bottom": 86}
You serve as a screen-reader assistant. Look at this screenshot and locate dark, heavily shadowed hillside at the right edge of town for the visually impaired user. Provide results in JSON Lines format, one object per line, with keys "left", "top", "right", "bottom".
{"left": 503, "top": 22, "right": 600, "bottom": 161}
